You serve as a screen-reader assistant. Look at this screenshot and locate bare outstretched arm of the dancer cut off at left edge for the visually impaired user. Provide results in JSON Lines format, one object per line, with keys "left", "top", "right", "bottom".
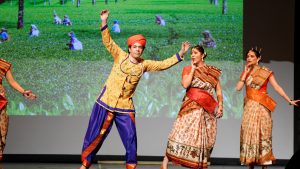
{"left": 5, "top": 70, "right": 36, "bottom": 100}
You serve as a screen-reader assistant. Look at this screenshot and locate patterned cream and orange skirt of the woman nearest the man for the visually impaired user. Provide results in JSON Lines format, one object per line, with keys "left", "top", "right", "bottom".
{"left": 166, "top": 100, "right": 217, "bottom": 169}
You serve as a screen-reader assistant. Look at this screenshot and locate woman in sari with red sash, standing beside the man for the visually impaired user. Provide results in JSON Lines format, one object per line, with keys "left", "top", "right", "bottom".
{"left": 161, "top": 45, "right": 223, "bottom": 169}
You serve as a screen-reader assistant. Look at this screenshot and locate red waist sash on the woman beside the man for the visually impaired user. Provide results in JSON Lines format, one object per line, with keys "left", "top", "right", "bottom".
{"left": 186, "top": 88, "right": 218, "bottom": 113}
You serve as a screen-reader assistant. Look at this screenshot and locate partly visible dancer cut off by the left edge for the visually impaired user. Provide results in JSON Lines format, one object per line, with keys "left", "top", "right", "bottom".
{"left": 0, "top": 58, "right": 36, "bottom": 161}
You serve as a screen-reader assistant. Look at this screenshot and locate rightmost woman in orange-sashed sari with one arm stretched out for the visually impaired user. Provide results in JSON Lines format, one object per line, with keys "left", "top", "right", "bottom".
{"left": 236, "top": 48, "right": 299, "bottom": 169}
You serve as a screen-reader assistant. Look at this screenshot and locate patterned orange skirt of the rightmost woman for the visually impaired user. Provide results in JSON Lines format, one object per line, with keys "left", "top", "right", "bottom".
{"left": 240, "top": 99, "right": 275, "bottom": 165}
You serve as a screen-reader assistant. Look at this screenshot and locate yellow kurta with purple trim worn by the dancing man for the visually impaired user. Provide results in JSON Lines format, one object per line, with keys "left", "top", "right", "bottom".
{"left": 97, "top": 25, "right": 182, "bottom": 113}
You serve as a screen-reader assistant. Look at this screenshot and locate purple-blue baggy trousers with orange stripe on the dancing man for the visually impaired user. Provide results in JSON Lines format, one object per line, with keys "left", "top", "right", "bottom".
{"left": 81, "top": 103, "right": 137, "bottom": 169}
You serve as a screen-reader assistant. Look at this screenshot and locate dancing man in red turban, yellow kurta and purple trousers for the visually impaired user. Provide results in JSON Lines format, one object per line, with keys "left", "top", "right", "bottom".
{"left": 80, "top": 10, "right": 190, "bottom": 169}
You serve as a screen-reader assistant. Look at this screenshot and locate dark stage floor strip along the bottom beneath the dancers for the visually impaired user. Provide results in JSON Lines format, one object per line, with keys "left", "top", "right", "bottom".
{"left": 0, "top": 163, "right": 284, "bottom": 169}
